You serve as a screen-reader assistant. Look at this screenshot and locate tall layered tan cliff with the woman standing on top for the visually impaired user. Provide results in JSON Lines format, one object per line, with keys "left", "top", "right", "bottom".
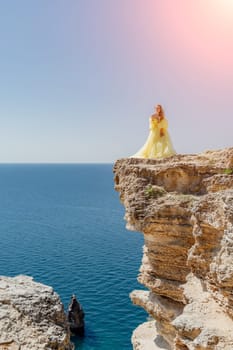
{"left": 114, "top": 148, "right": 233, "bottom": 350}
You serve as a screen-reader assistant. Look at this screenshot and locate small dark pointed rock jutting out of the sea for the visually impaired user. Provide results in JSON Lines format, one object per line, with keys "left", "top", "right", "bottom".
{"left": 68, "top": 295, "right": 85, "bottom": 336}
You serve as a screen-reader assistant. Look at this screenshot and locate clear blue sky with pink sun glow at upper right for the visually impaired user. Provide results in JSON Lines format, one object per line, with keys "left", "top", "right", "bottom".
{"left": 0, "top": 0, "right": 233, "bottom": 163}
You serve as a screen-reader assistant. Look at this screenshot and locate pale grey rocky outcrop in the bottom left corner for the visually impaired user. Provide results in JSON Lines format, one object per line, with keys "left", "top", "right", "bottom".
{"left": 0, "top": 276, "right": 74, "bottom": 350}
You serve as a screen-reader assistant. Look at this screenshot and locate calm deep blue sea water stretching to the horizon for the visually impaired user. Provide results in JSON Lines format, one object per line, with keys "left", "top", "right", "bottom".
{"left": 0, "top": 164, "right": 147, "bottom": 350}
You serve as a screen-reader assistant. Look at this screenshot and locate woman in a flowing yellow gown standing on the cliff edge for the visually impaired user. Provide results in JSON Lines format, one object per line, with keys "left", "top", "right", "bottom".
{"left": 130, "top": 105, "right": 176, "bottom": 158}
